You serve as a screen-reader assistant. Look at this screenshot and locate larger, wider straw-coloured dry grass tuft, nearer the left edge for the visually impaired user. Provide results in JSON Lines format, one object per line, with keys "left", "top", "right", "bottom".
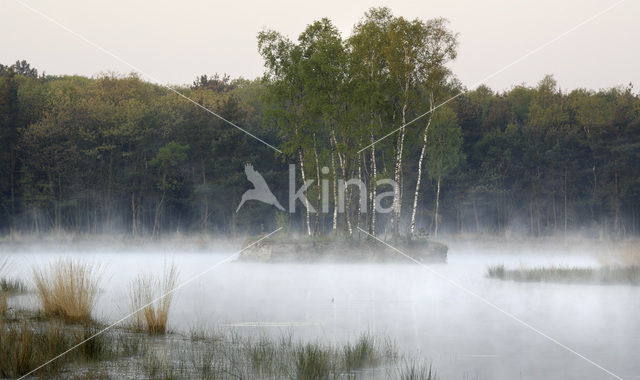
{"left": 33, "top": 259, "right": 102, "bottom": 322}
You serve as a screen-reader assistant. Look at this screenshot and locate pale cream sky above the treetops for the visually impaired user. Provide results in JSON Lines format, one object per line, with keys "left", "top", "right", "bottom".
{"left": 0, "top": 0, "right": 640, "bottom": 91}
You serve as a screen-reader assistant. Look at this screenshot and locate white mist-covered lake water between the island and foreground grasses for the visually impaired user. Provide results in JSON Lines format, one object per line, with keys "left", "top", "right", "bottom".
{"left": 2, "top": 242, "right": 640, "bottom": 379}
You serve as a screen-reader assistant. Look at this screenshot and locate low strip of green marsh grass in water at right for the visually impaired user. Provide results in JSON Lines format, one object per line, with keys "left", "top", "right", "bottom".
{"left": 487, "top": 265, "right": 640, "bottom": 285}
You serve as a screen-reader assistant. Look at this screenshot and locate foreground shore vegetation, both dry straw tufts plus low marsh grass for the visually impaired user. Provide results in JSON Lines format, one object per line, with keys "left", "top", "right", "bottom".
{"left": 0, "top": 256, "right": 437, "bottom": 380}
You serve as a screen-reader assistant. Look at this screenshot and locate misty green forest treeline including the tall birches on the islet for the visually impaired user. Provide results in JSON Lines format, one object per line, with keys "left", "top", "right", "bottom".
{"left": 0, "top": 8, "right": 640, "bottom": 236}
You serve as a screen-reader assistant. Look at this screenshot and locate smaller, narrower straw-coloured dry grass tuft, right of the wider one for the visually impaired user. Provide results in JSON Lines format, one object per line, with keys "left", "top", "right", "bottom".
{"left": 131, "top": 264, "right": 178, "bottom": 334}
